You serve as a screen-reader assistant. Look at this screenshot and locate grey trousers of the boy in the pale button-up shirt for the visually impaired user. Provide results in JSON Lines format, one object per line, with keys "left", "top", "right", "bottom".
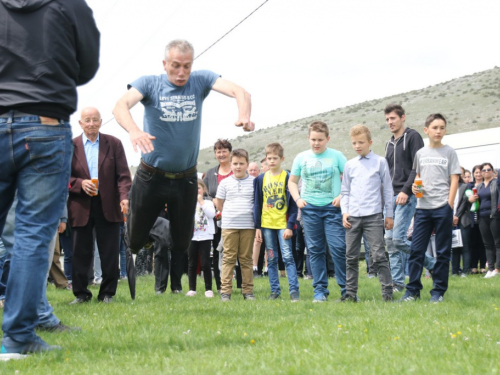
{"left": 345, "top": 213, "right": 392, "bottom": 296}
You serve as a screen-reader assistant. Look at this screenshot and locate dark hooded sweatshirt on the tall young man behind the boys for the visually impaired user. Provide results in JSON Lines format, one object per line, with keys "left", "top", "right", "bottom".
{"left": 385, "top": 128, "right": 424, "bottom": 196}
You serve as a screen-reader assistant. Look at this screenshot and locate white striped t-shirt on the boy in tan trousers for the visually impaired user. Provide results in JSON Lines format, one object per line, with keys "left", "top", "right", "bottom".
{"left": 216, "top": 175, "right": 255, "bottom": 229}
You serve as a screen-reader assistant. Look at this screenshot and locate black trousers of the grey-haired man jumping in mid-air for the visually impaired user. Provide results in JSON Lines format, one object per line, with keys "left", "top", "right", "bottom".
{"left": 127, "top": 166, "right": 198, "bottom": 253}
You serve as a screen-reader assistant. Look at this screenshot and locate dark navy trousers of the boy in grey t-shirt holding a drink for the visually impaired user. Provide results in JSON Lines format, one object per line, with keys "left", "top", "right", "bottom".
{"left": 406, "top": 204, "right": 453, "bottom": 297}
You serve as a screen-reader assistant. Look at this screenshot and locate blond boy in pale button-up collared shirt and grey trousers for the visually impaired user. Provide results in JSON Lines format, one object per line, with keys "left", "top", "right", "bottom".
{"left": 340, "top": 125, "right": 394, "bottom": 302}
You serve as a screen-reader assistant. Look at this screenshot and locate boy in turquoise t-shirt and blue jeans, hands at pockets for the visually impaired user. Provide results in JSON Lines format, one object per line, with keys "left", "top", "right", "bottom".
{"left": 288, "top": 121, "right": 346, "bottom": 302}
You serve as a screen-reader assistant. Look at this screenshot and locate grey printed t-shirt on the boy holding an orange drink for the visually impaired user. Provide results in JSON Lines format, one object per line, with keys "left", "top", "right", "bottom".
{"left": 413, "top": 145, "right": 462, "bottom": 210}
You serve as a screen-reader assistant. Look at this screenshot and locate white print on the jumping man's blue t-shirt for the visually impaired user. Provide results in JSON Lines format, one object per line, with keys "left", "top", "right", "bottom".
{"left": 158, "top": 95, "right": 198, "bottom": 122}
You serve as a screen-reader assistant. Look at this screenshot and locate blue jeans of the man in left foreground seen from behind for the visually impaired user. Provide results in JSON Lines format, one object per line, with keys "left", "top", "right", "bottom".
{"left": 0, "top": 116, "right": 73, "bottom": 343}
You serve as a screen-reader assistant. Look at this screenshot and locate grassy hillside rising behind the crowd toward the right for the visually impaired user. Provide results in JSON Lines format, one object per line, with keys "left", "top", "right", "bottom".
{"left": 198, "top": 67, "right": 500, "bottom": 172}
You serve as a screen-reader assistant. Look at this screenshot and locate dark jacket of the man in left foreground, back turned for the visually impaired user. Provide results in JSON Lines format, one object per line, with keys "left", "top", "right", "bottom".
{"left": 0, "top": 0, "right": 100, "bottom": 120}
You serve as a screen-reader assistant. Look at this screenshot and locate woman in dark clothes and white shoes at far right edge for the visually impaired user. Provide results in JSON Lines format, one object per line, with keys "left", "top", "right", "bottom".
{"left": 469, "top": 163, "right": 500, "bottom": 278}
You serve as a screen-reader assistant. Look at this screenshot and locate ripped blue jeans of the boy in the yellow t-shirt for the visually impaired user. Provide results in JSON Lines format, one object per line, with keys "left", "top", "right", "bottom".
{"left": 262, "top": 228, "right": 299, "bottom": 294}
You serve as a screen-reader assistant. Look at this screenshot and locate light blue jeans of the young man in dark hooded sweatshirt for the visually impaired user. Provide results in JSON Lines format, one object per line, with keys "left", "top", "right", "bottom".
{"left": 385, "top": 195, "right": 435, "bottom": 285}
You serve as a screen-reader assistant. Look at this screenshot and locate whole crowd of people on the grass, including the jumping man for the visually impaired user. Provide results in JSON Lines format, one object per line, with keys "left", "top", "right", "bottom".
{"left": 0, "top": 0, "right": 500, "bottom": 359}
